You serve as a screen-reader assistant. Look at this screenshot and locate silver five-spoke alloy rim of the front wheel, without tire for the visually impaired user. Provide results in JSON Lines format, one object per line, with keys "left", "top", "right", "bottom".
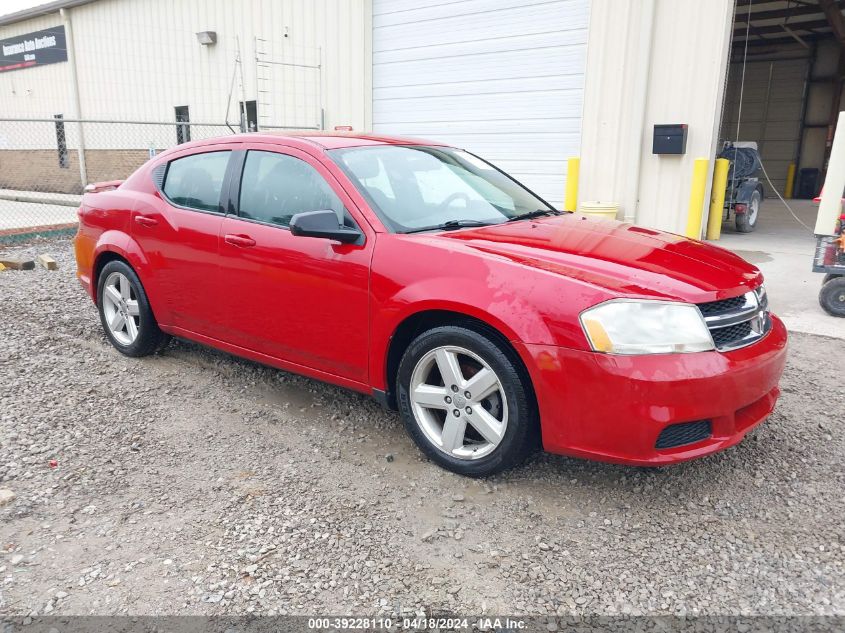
{"left": 410, "top": 346, "right": 508, "bottom": 460}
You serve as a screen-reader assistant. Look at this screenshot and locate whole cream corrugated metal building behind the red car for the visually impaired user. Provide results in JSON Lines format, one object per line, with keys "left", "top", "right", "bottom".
{"left": 0, "top": 0, "right": 841, "bottom": 232}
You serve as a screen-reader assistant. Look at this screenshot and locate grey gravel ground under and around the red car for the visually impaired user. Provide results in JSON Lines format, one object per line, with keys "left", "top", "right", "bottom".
{"left": 0, "top": 240, "right": 845, "bottom": 615}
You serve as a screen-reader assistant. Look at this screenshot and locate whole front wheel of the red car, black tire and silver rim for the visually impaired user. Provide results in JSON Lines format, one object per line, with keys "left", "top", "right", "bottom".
{"left": 396, "top": 325, "right": 539, "bottom": 477}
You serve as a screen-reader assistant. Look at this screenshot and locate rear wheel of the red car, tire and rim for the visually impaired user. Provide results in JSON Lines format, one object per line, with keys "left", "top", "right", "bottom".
{"left": 97, "top": 260, "right": 170, "bottom": 357}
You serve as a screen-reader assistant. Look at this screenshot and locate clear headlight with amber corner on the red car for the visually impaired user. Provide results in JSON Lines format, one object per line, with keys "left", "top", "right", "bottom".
{"left": 581, "top": 299, "right": 714, "bottom": 354}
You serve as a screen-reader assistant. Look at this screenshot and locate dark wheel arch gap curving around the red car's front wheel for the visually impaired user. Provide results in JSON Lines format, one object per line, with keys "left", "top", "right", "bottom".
{"left": 383, "top": 309, "right": 537, "bottom": 410}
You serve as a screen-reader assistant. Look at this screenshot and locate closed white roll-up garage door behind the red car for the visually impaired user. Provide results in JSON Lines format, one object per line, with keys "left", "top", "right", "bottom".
{"left": 373, "top": 0, "right": 589, "bottom": 204}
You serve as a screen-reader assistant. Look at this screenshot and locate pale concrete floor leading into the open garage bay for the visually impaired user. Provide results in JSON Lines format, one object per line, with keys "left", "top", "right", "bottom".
{"left": 713, "top": 198, "right": 845, "bottom": 339}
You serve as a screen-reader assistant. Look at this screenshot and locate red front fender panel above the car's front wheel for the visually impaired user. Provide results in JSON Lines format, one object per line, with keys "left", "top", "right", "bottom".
{"left": 370, "top": 234, "right": 606, "bottom": 389}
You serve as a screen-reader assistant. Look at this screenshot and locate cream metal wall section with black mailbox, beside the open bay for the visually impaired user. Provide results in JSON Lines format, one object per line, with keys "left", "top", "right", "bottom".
{"left": 579, "top": 0, "right": 734, "bottom": 233}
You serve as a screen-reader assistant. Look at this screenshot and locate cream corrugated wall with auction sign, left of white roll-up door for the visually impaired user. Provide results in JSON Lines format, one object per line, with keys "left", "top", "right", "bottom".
{"left": 0, "top": 0, "right": 372, "bottom": 143}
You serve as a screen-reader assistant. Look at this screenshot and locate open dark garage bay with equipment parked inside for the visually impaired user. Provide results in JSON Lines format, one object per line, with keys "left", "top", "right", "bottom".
{"left": 719, "top": 0, "right": 845, "bottom": 237}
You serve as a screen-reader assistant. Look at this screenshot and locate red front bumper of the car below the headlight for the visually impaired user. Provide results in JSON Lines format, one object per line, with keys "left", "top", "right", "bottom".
{"left": 517, "top": 315, "right": 787, "bottom": 466}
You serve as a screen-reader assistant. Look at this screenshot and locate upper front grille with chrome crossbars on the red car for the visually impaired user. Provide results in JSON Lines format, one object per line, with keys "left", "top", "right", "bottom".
{"left": 698, "top": 286, "right": 772, "bottom": 352}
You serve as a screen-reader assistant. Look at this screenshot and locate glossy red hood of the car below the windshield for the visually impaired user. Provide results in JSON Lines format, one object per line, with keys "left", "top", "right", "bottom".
{"left": 429, "top": 214, "right": 762, "bottom": 303}
